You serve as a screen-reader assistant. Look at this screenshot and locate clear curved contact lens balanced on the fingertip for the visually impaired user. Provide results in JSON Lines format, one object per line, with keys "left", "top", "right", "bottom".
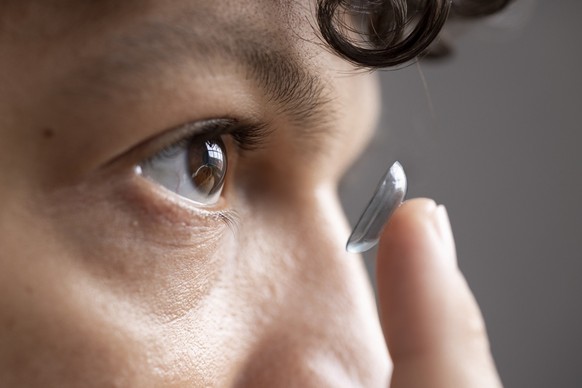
{"left": 346, "top": 162, "right": 406, "bottom": 253}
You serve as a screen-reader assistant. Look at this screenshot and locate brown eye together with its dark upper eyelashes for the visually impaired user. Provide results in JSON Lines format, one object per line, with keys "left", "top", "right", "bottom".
{"left": 136, "top": 119, "right": 265, "bottom": 207}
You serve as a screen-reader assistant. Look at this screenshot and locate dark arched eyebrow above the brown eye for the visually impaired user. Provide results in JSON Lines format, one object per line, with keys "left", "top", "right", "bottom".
{"left": 66, "top": 17, "right": 333, "bottom": 132}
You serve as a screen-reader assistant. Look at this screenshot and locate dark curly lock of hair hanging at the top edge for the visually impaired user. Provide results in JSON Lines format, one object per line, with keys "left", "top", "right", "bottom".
{"left": 317, "top": 0, "right": 511, "bottom": 68}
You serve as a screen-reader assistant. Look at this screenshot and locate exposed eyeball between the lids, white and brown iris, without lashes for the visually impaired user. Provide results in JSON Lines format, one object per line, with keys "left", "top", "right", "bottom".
{"left": 138, "top": 137, "right": 228, "bottom": 205}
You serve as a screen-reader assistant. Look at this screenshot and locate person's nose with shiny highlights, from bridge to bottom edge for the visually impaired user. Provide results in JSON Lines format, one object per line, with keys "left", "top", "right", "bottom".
{"left": 237, "top": 187, "right": 388, "bottom": 387}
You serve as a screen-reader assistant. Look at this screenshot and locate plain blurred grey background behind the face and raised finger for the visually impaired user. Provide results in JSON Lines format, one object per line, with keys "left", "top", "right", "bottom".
{"left": 341, "top": 0, "right": 582, "bottom": 387}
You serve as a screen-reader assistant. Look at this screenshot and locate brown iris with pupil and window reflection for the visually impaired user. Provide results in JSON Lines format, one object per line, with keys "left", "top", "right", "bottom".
{"left": 188, "top": 138, "right": 226, "bottom": 195}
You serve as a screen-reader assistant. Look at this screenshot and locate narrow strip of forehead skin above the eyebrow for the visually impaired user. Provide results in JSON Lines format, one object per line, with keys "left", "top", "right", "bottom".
{"left": 0, "top": 0, "right": 302, "bottom": 37}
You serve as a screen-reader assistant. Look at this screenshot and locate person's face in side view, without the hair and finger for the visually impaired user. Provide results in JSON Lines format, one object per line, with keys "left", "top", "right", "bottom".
{"left": 0, "top": 0, "right": 388, "bottom": 387}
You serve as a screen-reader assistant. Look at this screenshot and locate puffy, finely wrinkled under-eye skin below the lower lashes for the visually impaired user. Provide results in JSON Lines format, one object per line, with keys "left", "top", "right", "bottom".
{"left": 39, "top": 178, "right": 240, "bottom": 322}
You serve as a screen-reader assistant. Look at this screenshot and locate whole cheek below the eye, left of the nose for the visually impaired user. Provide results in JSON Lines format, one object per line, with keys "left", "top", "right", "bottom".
{"left": 0, "top": 182, "right": 241, "bottom": 386}
